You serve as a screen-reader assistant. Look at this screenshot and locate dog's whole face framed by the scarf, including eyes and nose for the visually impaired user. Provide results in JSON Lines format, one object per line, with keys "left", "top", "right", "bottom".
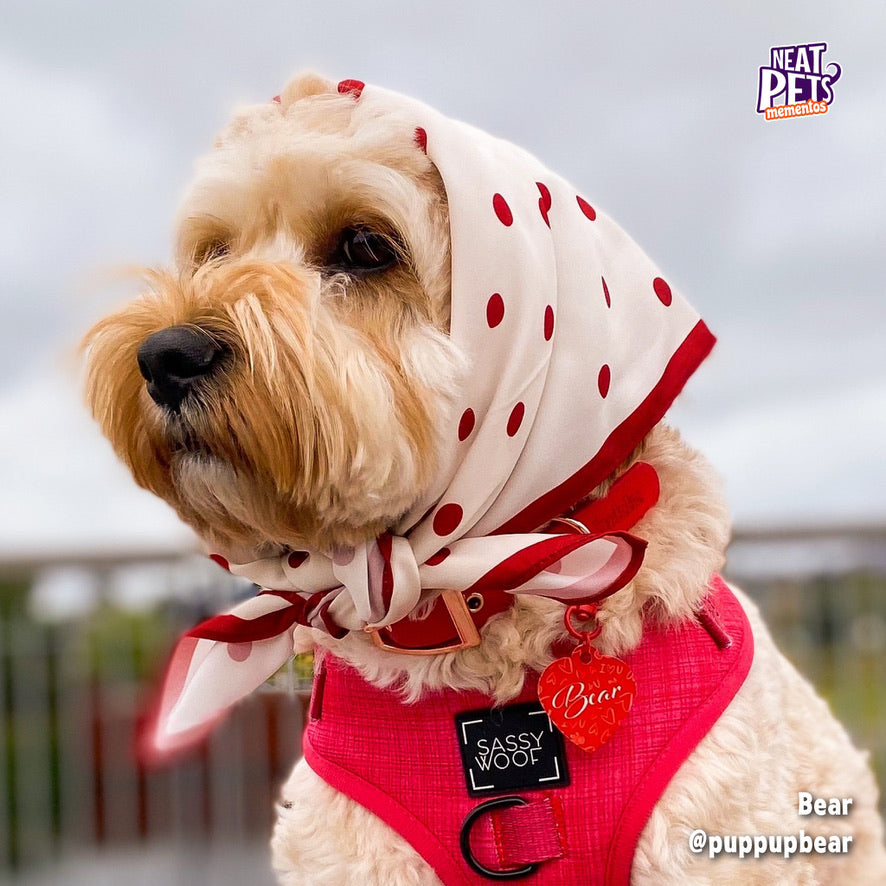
{"left": 87, "top": 76, "right": 463, "bottom": 556}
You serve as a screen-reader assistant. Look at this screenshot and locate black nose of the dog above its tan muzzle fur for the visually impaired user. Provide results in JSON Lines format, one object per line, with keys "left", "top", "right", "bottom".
{"left": 138, "top": 326, "right": 223, "bottom": 412}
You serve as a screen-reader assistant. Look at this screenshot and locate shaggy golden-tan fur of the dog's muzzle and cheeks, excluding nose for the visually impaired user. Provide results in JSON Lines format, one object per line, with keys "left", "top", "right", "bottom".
{"left": 87, "top": 261, "right": 460, "bottom": 552}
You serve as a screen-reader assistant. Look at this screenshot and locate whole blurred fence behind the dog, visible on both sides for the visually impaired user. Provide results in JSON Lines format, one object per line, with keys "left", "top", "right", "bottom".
{"left": 0, "top": 540, "right": 886, "bottom": 886}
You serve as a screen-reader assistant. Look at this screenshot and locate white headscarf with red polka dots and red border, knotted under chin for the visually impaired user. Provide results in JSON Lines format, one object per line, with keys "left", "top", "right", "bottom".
{"left": 144, "top": 81, "right": 714, "bottom": 746}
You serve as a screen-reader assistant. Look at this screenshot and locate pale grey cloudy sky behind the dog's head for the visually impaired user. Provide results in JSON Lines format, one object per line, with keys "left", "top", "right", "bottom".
{"left": 0, "top": 0, "right": 886, "bottom": 555}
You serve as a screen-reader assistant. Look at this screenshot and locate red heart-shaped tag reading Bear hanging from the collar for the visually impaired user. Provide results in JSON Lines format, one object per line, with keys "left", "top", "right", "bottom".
{"left": 538, "top": 644, "right": 637, "bottom": 751}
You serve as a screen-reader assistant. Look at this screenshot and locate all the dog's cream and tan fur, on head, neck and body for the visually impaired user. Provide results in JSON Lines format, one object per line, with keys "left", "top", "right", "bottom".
{"left": 87, "top": 75, "right": 886, "bottom": 886}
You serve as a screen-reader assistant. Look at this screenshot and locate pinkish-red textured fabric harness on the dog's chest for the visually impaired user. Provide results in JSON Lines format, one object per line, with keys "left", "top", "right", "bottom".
{"left": 304, "top": 576, "right": 753, "bottom": 886}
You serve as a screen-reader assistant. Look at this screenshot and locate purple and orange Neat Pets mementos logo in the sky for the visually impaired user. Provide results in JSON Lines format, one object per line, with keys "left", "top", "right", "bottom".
{"left": 757, "top": 43, "right": 842, "bottom": 120}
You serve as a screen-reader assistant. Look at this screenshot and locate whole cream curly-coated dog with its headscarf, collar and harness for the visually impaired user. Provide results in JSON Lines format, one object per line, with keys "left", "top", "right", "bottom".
{"left": 80, "top": 74, "right": 886, "bottom": 886}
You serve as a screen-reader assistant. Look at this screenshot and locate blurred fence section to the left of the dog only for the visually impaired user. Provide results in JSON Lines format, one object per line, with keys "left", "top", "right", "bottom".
{"left": 0, "top": 564, "right": 302, "bottom": 886}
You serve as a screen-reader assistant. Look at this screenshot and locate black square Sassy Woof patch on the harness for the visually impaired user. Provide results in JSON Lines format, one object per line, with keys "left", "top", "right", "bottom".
{"left": 455, "top": 702, "right": 569, "bottom": 797}
